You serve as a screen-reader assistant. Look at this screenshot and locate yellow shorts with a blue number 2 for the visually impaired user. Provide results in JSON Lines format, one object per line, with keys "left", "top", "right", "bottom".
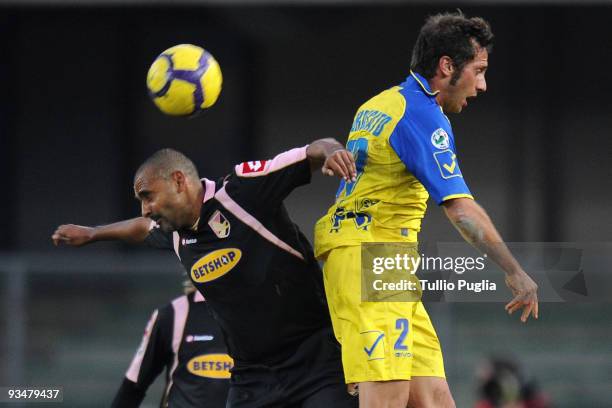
{"left": 323, "top": 246, "right": 446, "bottom": 383}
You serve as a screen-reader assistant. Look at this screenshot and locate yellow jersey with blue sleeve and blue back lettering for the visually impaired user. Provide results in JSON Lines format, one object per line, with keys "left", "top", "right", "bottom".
{"left": 315, "top": 72, "right": 472, "bottom": 258}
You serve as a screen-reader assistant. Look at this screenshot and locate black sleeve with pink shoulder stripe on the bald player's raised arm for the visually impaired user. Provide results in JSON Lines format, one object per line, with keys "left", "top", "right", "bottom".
{"left": 226, "top": 146, "right": 311, "bottom": 207}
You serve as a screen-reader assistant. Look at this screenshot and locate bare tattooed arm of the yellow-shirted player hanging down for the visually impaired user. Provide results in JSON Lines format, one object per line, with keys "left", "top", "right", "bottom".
{"left": 442, "top": 198, "right": 538, "bottom": 322}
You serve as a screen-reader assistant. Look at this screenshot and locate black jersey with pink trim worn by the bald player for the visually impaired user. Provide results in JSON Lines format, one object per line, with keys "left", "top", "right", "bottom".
{"left": 147, "top": 147, "right": 331, "bottom": 364}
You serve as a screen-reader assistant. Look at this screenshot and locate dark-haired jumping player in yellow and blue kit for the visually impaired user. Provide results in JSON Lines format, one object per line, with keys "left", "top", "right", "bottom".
{"left": 315, "top": 12, "right": 538, "bottom": 408}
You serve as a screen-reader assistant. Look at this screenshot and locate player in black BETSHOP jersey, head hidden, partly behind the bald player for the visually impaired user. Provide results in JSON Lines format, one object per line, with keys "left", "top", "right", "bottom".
{"left": 112, "top": 281, "right": 234, "bottom": 408}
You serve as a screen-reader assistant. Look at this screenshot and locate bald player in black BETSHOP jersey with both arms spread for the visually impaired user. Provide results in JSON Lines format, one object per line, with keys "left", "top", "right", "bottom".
{"left": 52, "top": 139, "right": 357, "bottom": 408}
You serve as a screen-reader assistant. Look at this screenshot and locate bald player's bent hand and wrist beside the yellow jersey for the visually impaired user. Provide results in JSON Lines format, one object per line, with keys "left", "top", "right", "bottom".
{"left": 306, "top": 138, "right": 357, "bottom": 181}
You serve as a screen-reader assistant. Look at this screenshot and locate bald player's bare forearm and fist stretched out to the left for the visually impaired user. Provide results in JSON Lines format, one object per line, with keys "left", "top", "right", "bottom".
{"left": 51, "top": 217, "right": 151, "bottom": 247}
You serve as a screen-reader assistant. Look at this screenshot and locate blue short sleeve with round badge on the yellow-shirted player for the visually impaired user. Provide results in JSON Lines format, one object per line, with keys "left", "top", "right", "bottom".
{"left": 389, "top": 106, "right": 473, "bottom": 204}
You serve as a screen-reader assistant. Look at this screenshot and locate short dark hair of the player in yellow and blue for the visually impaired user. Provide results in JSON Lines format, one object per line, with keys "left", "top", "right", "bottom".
{"left": 410, "top": 10, "right": 493, "bottom": 84}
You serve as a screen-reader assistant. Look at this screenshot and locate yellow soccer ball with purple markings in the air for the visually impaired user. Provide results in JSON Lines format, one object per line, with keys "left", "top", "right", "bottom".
{"left": 147, "top": 44, "right": 223, "bottom": 116}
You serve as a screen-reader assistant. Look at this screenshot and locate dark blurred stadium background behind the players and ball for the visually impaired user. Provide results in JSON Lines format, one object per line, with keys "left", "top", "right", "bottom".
{"left": 0, "top": 0, "right": 612, "bottom": 407}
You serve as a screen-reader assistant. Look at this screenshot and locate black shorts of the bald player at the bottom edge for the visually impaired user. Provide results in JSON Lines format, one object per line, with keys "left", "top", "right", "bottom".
{"left": 226, "top": 328, "right": 359, "bottom": 408}
